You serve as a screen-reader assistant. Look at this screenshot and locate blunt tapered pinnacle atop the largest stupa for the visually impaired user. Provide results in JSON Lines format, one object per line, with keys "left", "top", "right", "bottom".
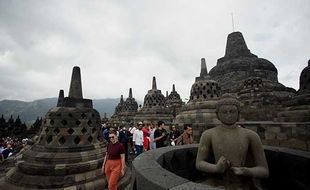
{"left": 225, "top": 32, "right": 257, "bottom": 58}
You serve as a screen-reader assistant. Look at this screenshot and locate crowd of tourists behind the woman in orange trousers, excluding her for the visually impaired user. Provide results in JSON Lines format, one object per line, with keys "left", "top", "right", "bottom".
{"left": 102, "top": 121, "right": 193, "bottom": 162}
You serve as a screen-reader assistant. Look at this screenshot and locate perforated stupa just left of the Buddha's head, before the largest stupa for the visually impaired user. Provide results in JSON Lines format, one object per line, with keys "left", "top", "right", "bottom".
{"left": 176, "top": 58, "right": 221, "bottom": 139}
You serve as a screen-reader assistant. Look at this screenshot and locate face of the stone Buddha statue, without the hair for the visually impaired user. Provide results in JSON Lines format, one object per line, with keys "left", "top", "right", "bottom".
{"left": 217, "top": 105, "right": 239, "bottom": 125}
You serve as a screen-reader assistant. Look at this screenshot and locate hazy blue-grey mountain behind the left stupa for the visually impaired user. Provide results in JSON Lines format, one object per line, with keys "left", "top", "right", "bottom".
{"left": 0, "top": 98, "right": 119, "bottom": 123}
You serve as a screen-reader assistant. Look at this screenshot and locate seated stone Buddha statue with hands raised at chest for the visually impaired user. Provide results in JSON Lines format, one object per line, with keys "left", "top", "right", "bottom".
{"left": 196, "top": 96, "right": 269, "bottom": 189}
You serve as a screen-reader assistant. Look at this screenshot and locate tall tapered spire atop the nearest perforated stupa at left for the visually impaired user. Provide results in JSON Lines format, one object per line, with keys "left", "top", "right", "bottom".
{"left": 69, "top": 66, "right": 83, "bottom": 99}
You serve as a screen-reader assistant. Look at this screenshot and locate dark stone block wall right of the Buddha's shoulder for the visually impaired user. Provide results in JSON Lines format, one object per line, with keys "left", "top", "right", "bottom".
{"left": 239, "top": 121, "right": 310, "bottom": 151}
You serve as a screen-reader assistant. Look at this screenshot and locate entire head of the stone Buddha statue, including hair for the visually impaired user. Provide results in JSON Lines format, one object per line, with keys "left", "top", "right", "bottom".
{"left": 216, "top": 95, "right": 240, "bottom": 125}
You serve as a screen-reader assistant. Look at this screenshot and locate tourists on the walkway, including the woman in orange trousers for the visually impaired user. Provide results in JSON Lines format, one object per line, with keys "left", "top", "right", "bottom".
{"left": 102, "top": 121, "right": 193, "bottom": 190}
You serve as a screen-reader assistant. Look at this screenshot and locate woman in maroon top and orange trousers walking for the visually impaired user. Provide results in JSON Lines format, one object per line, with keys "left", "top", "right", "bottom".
{"left": 102, "top": 131, "right": 125, "bottom": 190}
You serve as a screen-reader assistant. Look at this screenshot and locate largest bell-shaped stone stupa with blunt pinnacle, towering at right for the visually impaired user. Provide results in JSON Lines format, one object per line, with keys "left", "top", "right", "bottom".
{"left": 210, "top": 32, "right": 291, "bottom": 95}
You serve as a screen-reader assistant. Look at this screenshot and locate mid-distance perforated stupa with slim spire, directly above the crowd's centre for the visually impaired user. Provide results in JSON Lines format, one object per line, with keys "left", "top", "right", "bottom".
{"left": 134, "top": 77, "right": 174, "bottom": 124}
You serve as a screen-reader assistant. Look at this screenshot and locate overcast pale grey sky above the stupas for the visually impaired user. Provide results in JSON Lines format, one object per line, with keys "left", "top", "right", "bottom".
{"left": 0, "top": 0, "right": 310, "bottom": 101}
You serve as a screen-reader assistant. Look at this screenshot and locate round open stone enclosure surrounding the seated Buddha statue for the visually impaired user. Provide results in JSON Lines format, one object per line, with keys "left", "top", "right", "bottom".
{"left": 131, "top": 144, "right": 310, "bottom": 190}
